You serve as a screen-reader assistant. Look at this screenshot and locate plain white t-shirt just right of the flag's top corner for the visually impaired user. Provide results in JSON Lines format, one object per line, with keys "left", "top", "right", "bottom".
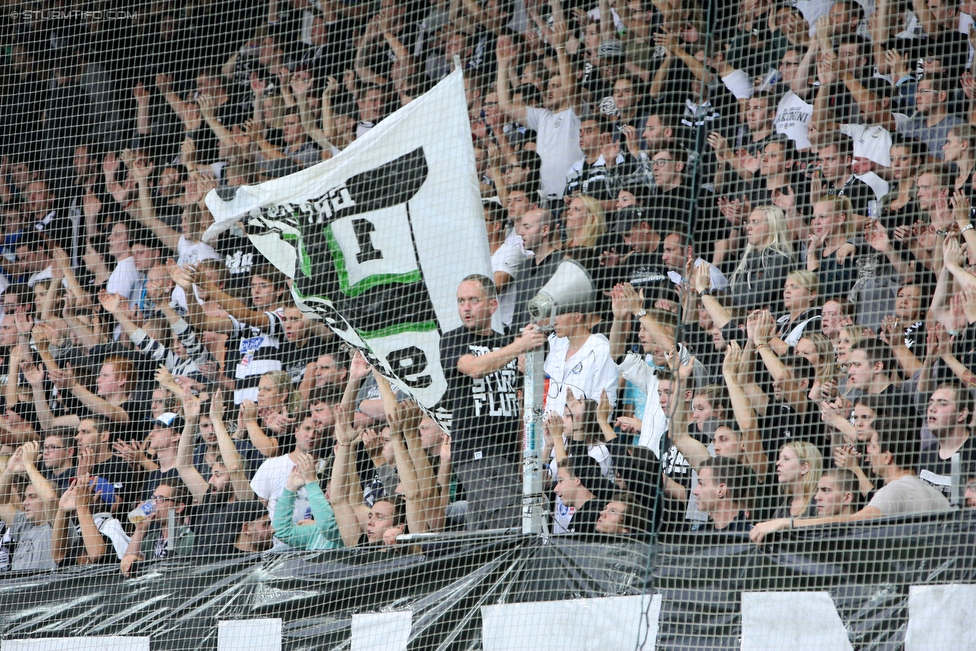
{"left": 525, "top": 107, "right": 583, "bottom": 197}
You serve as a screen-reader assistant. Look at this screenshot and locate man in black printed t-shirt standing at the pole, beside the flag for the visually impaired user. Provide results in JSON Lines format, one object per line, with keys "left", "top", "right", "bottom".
{"left": 440, "top": 274, "right": 546, "bottom": 531}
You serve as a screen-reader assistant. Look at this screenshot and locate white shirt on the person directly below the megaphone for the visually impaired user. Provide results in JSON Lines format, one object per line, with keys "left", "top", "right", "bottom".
{"left": 543, "top": 334, "right": 620, "bottom": 415}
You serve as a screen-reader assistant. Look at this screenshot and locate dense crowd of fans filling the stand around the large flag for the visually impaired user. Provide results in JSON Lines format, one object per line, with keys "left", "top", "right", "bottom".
{"left": 0, "top": 0, "right": 976, "bottom": 575}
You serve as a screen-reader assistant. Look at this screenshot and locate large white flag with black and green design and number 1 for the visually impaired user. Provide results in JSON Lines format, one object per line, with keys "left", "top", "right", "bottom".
{"left": 204, "top": 71, "right": 491, "bottom": 426}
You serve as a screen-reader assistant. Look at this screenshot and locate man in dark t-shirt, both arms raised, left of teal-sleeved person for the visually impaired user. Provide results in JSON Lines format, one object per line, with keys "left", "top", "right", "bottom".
{"left": 176, "top": 391, "right": 274, "bottom": 559}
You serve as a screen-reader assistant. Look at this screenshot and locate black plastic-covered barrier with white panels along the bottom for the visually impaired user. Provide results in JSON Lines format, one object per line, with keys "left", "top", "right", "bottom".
{"left": 0, "top": 512, "right": 976, "bottom": 651}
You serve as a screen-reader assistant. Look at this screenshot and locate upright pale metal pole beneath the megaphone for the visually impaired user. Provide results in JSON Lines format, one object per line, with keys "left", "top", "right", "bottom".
{"left": 522, "top": 349, "right": 547, "bottom": 534}
